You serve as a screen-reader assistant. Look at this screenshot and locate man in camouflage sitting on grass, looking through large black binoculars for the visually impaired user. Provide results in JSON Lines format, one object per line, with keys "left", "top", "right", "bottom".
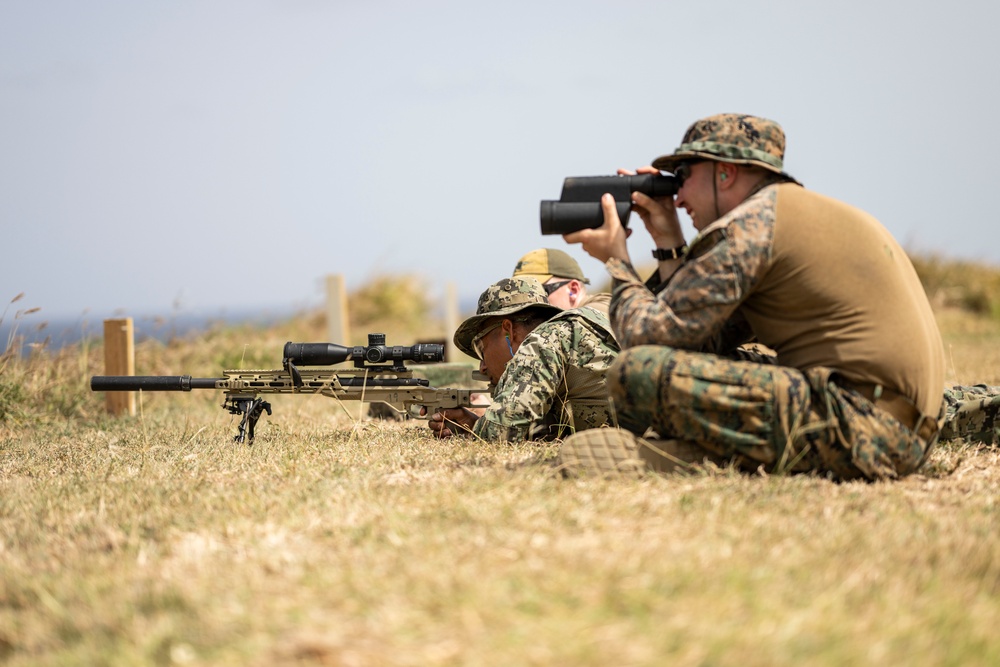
{"left": 564, "top": 114, "right": 944, "bottom": 479}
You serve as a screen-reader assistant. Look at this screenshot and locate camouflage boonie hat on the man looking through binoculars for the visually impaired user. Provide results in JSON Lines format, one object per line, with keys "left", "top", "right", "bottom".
{"left": 653, "top": 113, "right": 798, "bottom": 183}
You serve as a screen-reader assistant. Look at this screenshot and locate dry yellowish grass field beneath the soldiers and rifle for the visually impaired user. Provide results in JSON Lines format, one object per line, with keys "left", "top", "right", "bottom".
{"left": 0, "top": 268, "right": 1000, "bottom": 667}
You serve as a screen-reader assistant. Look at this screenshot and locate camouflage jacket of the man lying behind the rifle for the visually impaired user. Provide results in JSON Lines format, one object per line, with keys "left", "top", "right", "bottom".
{"left": 473, "top": 308, "right": 620, "bottom": 442}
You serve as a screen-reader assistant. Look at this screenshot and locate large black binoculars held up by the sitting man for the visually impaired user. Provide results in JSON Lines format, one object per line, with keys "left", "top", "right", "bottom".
{"left": 539, "top": 174, "right": 678, "bottom": 234}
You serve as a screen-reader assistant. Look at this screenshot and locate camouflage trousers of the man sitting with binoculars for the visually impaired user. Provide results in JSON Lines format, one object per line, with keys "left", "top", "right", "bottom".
{"left": 608, "top": 346, "right": 936, "bottom": 480}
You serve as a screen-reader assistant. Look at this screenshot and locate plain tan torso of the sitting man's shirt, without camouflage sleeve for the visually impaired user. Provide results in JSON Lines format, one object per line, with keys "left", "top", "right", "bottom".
{"left": 742, "top": 180, "right": 944, "bottom": 415}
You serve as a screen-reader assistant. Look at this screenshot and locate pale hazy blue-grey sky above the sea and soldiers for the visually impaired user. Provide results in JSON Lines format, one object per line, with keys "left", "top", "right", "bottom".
{"left": 0, "top": 0, "right": 1000, "bottom": 317}
